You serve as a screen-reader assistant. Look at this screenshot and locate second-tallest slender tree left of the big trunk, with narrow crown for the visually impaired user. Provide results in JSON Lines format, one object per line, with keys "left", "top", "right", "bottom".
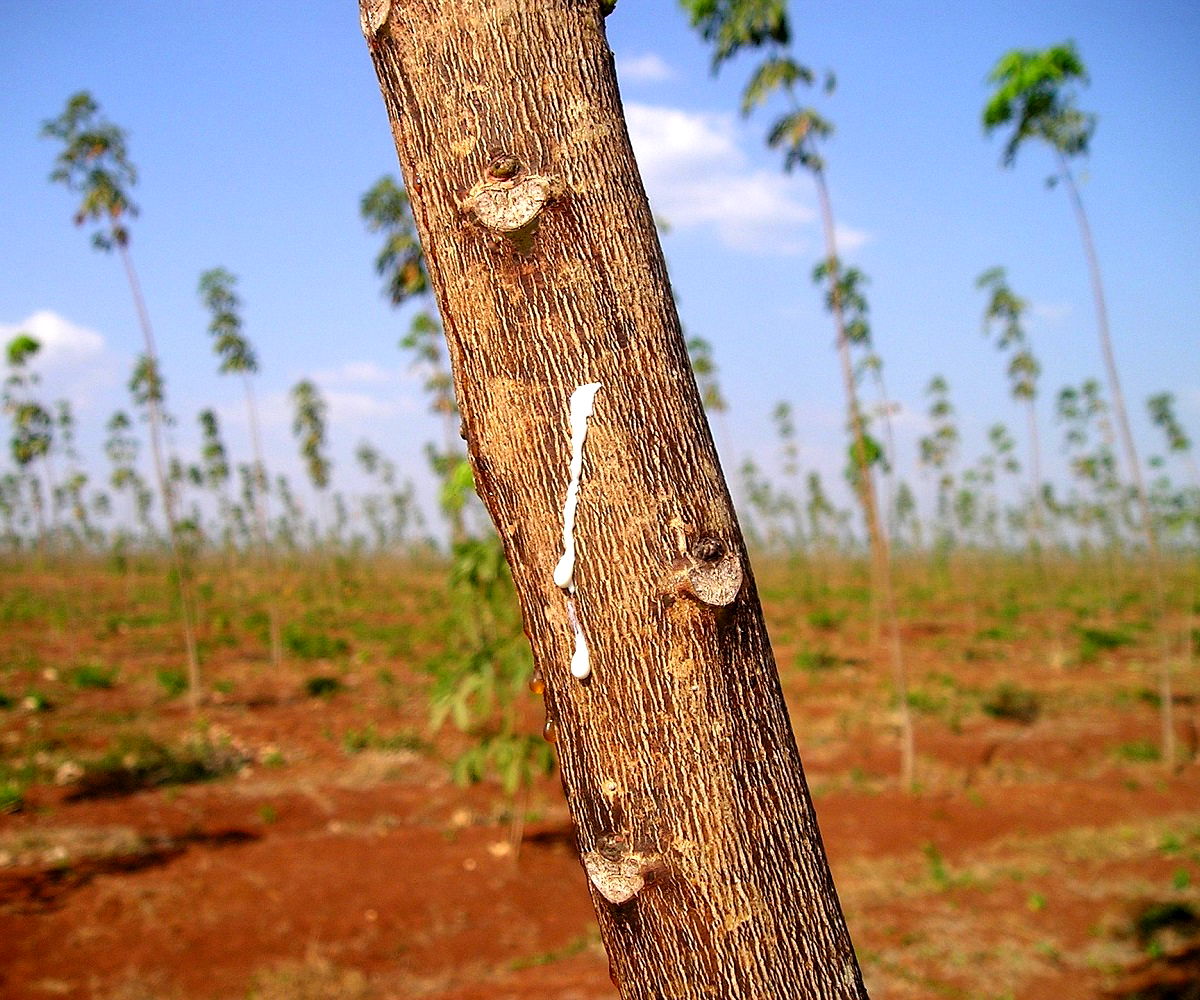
{"left": 199, "top": 268, "right": 283, "bottom": 666}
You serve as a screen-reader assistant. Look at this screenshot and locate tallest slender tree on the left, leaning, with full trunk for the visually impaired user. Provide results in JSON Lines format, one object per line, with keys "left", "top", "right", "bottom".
{"left": 42, "top": 91, "right": 200, "bottom": 711}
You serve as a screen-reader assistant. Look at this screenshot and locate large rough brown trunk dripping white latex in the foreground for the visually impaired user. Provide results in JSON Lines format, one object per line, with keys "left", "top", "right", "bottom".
{"left": 361, "top": 0, "right": 866, "bottom": 1000}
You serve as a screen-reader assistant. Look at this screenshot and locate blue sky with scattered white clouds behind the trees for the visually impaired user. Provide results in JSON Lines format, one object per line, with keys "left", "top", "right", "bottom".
{"left": 0, "top": 0, "right": 1200, "bottom": 530}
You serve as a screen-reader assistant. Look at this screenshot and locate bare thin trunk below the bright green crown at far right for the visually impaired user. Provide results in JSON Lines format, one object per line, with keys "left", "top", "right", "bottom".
{"left": 1058, "top": 152, "right": 1175, "bottom": 768}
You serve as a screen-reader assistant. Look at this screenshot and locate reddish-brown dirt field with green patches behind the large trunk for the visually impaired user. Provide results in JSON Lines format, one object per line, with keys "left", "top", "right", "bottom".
{"left": 0, "top": 563, "right": 1200, "bottom": 1000}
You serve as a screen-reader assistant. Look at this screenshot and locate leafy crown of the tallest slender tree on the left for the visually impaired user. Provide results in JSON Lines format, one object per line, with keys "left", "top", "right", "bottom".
{"left": 42, "top": 91, "right": 138, "bottom": 252}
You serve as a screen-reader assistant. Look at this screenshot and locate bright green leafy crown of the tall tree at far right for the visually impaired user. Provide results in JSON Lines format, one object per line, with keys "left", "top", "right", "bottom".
{"left": 983, "top": 42, "right": 1096, "bottom": 167}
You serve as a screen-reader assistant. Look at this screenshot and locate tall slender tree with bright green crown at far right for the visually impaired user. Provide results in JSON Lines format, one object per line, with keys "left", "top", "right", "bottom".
{"left": 983, "top": 42, "right": 1175, "bottom": 767}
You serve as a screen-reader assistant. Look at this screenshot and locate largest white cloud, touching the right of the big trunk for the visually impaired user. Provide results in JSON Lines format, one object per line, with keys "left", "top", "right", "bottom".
{"left": 625, "top": 103, "right": 830, "bottom": 255}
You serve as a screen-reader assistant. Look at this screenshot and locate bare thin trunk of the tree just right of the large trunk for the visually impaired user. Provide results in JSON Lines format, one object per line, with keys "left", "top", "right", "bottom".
{"left": 812, "top": 169, "right": 917, "bottom": 789}
